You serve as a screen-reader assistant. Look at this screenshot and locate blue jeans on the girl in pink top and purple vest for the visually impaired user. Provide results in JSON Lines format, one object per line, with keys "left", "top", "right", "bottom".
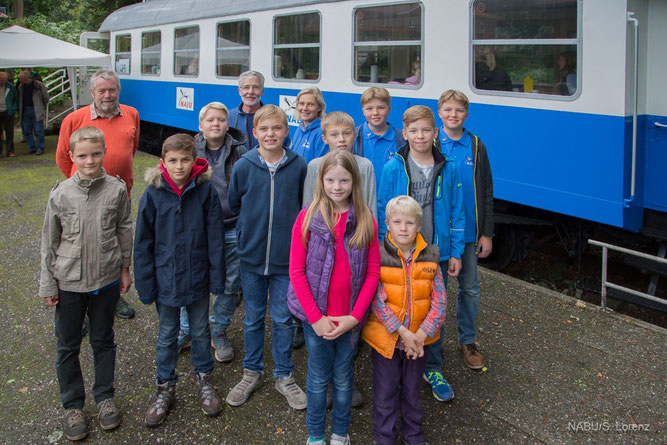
{"left": 303, "top": 323, "right": 359, "bottom": 439}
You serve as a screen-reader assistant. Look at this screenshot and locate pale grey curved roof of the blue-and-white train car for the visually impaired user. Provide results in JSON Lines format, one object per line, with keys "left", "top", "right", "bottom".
{"left": 99, "top": 0, "right": 340, "bottom": 32}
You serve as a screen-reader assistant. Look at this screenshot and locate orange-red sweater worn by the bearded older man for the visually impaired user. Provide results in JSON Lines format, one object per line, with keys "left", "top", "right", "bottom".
{"left": 56, "top": 105, "right": 139, "bottom": 196}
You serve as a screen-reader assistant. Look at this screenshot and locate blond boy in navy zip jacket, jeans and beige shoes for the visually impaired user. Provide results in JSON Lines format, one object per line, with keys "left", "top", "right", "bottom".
{"left": 227, "top": 105, "right": 307, "bottom": 409}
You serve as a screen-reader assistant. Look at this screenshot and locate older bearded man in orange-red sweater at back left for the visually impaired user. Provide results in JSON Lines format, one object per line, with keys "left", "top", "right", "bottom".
{"left": 56, "top": 70, "right": 139, "bottom": 318}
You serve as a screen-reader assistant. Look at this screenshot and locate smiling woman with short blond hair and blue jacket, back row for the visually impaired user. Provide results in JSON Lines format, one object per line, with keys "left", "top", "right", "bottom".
{"left": 291, "top": 87, "right": 328, "bottom": 162}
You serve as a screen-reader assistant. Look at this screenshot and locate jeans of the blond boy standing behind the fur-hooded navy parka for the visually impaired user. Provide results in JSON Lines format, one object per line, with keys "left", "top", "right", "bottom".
{"left": 181, "top": 229, "right": 241, "bottom": 336}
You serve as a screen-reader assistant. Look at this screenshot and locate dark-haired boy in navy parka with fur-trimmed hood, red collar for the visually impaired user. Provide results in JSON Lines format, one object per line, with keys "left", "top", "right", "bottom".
{"left": 134, "top": 134, "right": 225, "bottom": 427}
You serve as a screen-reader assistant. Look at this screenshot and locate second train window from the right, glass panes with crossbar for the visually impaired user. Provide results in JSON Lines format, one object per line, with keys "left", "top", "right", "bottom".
{"left": 352, "top": 2, "right": 424, "bottom": 88}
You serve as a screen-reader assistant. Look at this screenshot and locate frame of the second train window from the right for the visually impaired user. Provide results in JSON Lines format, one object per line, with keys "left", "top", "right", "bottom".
{"left": 350, "top": 1, "right": 426, "bottom": 90}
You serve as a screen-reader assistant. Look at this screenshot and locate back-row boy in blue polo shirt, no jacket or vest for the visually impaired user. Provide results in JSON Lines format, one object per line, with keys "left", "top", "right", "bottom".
{"left": 352, "top": 87, "right": 405, "bottom": 187}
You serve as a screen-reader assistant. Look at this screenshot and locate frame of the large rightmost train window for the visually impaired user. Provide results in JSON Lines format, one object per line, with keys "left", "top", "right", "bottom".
{"left": 468, "top": 0, "right": 584, "bottom": 102}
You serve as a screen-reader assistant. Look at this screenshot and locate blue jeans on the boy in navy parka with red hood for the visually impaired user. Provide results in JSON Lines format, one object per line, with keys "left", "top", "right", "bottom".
{"left": 155, "top": 298, "right": 213, "bottom": 384}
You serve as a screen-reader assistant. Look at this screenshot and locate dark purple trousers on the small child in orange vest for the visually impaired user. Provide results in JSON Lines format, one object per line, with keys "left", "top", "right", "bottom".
{"left": 373, "top": 349, "right": 426, "bottom": 445}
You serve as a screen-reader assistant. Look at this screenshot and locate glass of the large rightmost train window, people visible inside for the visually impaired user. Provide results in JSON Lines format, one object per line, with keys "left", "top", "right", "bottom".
{"left": 470, "top": 0, "right": 581, "bottom": 99}
